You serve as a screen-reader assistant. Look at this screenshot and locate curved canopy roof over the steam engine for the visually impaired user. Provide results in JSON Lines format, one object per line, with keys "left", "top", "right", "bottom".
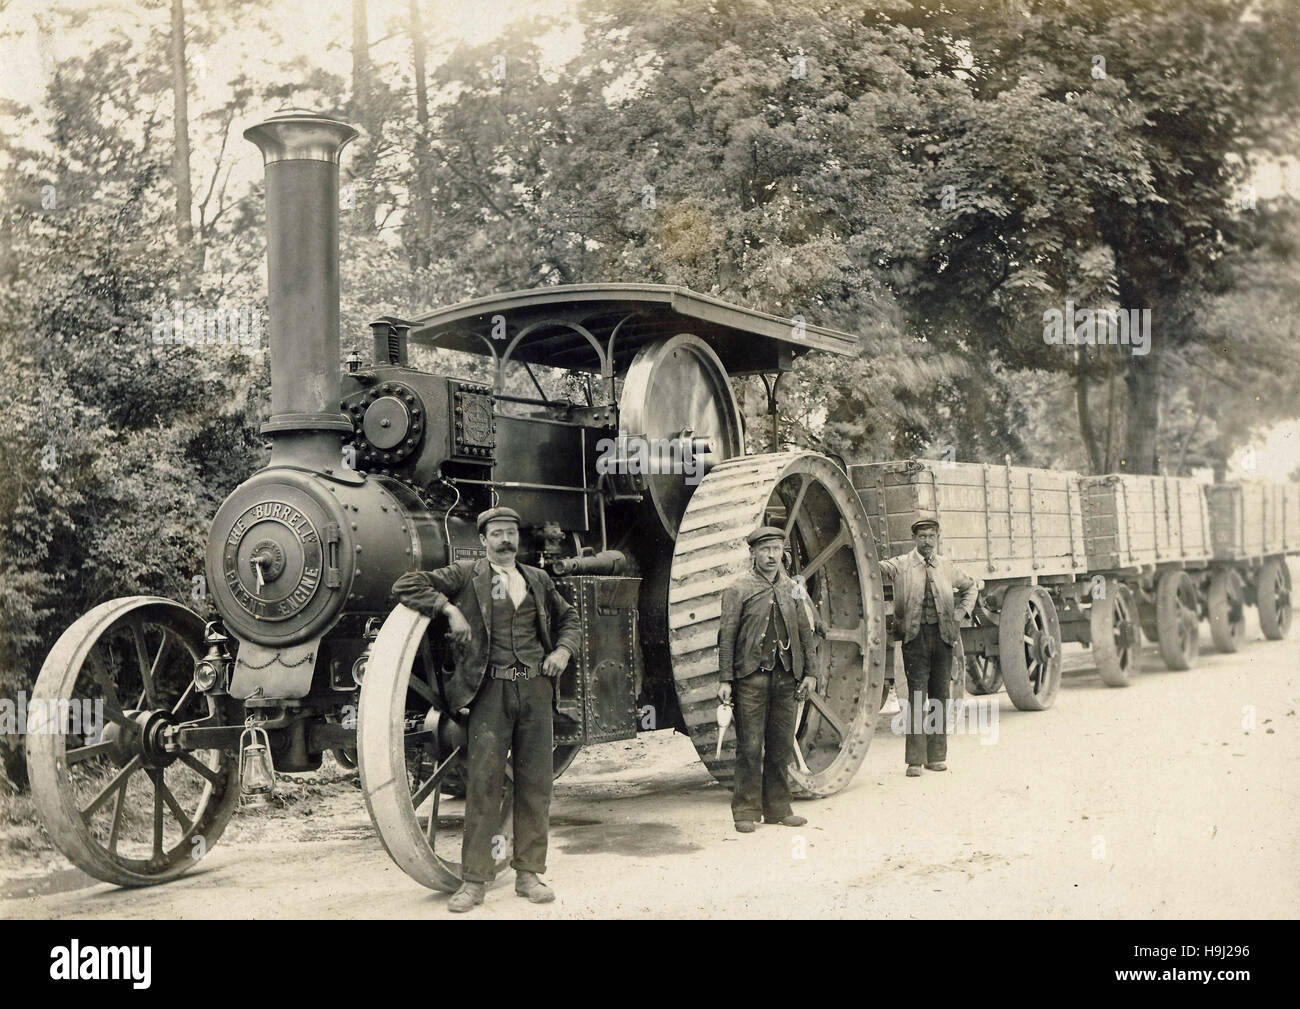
{"left": 410, "top": 283, "right": 859, "bottom": 376}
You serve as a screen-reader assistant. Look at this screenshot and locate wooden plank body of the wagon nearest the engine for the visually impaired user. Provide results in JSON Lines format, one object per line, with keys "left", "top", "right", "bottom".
{"left": 849, "top": 459, "right": 1087, "bottom": 581}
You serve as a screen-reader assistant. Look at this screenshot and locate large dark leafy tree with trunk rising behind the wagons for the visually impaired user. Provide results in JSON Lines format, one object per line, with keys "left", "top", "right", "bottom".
{"left": 900, "top": 0, "right": 1300, "bottom": 472}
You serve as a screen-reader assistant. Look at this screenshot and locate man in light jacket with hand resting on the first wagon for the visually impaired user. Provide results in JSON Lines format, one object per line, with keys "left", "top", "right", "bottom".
{"left": 880, "top": 511, "right": 979, "bottom": 778}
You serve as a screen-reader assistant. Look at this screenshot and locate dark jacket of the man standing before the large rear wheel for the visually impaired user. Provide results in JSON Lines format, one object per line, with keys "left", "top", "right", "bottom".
{"left": 718, "top": 568, "right": 815, "bottom": 683}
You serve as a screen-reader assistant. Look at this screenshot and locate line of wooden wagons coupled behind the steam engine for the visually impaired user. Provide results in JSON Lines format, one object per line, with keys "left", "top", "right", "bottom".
{"left": 849, "top": 459, "right": 1300, "bottom": 711}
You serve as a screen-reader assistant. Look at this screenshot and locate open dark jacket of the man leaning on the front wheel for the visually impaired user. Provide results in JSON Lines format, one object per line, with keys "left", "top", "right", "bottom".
{"left": 393, "top": 558, "right": 581, "bottom": 713}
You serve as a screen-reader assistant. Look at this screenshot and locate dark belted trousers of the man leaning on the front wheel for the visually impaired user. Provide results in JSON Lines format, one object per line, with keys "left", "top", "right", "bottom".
{"left": 460, "top": 671, "right": 555, "bottom": 883}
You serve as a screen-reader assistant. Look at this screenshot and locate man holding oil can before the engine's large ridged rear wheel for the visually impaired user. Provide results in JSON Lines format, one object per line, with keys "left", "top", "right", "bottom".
{"left": 718, "top": 525, "right": 816, "bottom": 833}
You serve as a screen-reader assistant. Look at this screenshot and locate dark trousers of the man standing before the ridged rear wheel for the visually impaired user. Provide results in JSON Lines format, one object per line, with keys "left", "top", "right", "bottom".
{"left": 732, "top": 670, "right": 796, "bottom": 823}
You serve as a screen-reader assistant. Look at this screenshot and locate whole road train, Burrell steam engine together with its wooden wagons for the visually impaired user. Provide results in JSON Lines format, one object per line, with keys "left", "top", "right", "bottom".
{"left": 26, "top": 111, "right": 1300, "bottom": 892}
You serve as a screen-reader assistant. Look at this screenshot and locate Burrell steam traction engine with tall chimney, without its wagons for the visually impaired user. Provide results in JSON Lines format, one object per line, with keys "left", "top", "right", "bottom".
{"left": 27, "top": 112, "right": 885, "bottom": 891}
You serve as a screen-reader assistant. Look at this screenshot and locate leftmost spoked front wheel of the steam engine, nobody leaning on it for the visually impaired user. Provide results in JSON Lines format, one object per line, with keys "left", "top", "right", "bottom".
{"left": 26, "top": 596, "right": 239, "bottom": 887}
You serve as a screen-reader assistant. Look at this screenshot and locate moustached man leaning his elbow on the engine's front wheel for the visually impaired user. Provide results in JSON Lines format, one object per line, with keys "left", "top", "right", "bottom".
{"left": 393, "top": 508, "right": 581, "bottom": 911}
